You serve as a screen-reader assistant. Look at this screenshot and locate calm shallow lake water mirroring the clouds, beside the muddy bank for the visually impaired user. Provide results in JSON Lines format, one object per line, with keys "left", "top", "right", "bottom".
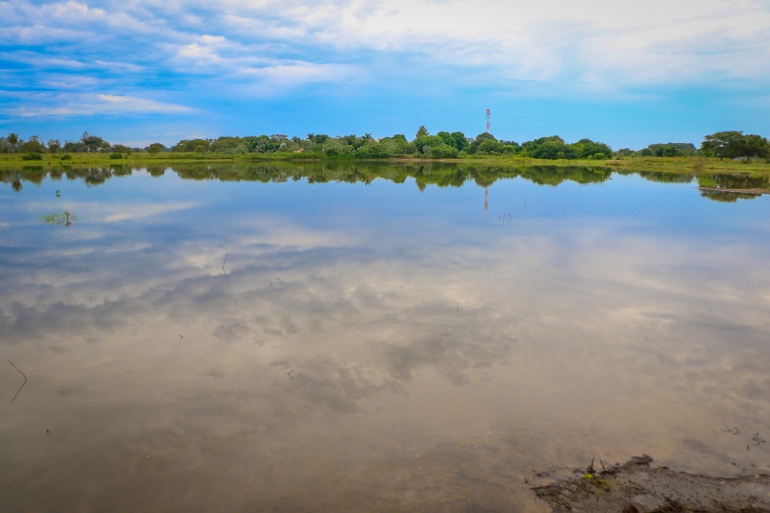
{"left": 0, "top": 165, "right": 770, "bottom": 512}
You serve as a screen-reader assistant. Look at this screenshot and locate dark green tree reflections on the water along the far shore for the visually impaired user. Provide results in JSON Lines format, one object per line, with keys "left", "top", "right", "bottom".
{"left": 0, "top": 162, "right": 770, "bottom": 201}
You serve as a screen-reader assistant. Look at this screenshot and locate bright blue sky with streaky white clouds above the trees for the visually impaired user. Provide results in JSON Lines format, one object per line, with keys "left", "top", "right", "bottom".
{"left": 0, "top": 0, "right": 770, "bottom": 149}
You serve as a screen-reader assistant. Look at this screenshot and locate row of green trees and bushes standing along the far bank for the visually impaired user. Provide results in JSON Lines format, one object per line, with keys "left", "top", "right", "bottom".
{"left": 0, "top": 126, "right": 770, "bottom": 160}
